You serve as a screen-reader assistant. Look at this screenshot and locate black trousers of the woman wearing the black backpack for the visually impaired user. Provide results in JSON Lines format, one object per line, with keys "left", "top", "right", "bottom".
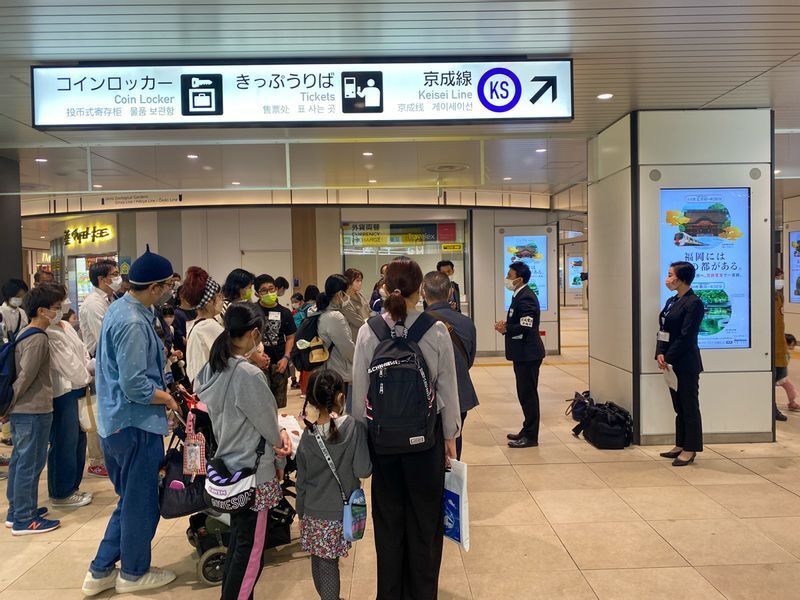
{"left": 370, "top": 421, "right": 445, "bottom": 600}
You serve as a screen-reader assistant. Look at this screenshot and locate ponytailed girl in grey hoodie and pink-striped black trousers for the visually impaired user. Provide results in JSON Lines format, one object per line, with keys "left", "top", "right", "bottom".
{"left": 196, "top": 303, "right": 291, "bottom": 600}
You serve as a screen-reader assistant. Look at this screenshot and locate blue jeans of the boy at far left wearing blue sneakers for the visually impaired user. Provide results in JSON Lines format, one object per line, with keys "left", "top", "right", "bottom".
{"left": 6, "top": 413, "right": 53, "bottom": 526}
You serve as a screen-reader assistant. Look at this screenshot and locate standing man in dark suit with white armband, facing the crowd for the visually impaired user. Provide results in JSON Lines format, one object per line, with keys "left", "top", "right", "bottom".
{"left": 494, "top": 262, "right": 545, "bottom": 448}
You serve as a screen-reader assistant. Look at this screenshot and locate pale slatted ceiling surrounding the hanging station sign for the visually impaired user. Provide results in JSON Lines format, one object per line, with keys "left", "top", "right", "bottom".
{"left": 0, "top": 0, "right": 800, "bottom": 190}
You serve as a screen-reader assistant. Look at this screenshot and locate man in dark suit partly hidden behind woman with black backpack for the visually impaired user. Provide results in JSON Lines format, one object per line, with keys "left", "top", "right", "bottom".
{"left": 422, "top": 271, "right": 478, "bottom": 460}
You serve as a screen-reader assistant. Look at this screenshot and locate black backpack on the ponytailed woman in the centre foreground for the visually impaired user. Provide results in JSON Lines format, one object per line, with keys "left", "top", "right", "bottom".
{"left": 367, "top": 313, "right": 438, "bottom": 454}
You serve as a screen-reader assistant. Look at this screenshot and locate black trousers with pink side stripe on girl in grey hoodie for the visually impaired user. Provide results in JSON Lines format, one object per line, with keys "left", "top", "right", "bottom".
{"left": 221, "top": 510, "right": 268, "bottom": 600}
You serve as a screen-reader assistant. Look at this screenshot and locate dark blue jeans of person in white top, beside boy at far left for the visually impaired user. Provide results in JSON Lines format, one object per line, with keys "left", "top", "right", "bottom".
{"left": 47, "top": 388, "right": 86, "bottom": 500}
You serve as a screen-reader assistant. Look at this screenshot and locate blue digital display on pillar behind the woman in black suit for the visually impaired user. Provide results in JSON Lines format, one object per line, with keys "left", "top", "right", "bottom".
{"left": 660, "top": 188, "right": 750, "bottom": 349}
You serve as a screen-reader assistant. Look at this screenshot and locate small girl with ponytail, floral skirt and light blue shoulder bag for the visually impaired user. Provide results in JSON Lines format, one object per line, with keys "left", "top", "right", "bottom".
{"left": 297, "top": 368, "right": 372, "bottom": 600}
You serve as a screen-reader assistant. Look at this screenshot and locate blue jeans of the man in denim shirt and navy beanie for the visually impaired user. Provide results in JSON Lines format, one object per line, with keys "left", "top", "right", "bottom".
{"left": 89, "top": 427, "right": 164, "bottom": 581}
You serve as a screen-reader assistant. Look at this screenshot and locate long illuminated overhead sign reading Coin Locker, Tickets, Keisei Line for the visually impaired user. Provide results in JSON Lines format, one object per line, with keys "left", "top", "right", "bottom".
{"left": 31, "top": 59, "right": 573, "bottom": 129}
